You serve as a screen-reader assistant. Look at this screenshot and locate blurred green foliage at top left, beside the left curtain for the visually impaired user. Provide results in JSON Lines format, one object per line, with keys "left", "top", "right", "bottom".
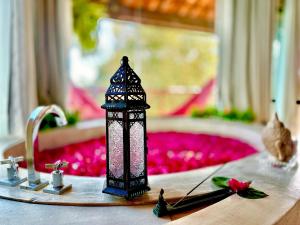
{"left": 73, "top": 0, "right": 106, "bottom": 52}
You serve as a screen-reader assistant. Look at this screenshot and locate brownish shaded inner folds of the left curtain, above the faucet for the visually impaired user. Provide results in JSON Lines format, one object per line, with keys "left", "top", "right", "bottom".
{"left": 35, "top": 0, "right": 72, "bottom": 106}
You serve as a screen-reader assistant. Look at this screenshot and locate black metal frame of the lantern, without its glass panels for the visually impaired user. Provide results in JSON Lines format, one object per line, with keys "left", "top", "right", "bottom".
{"left": 101, "top": 56, "right": 150, "bottom": 199}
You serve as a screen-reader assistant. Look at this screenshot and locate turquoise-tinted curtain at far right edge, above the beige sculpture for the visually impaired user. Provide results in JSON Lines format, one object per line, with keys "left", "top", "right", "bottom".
{"left": 273, "top": 0, "right": 300, "bottom": 129}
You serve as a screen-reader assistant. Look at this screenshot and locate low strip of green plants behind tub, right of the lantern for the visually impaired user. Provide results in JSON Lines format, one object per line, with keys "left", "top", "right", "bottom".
{"left": 191, "top": 107, "right": 255, "bottom": 122}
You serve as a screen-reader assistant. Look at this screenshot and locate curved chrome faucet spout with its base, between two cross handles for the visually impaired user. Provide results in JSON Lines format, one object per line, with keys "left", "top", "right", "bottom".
{"left": 20, "top": 105, "right": 67, "bottom": 191}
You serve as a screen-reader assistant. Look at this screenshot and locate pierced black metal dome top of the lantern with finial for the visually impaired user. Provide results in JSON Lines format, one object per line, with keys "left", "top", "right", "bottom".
{"left": 101, "top": 56, "right": 150, "bottom": 110}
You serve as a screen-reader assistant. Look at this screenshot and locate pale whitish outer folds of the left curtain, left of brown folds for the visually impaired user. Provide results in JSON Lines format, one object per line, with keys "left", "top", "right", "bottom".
{"left": 8, "top": 0, "right": 38, "bottom": 135}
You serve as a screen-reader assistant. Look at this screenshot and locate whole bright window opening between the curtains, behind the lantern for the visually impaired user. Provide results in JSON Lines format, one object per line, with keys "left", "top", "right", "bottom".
{"left": 69, "top": 0, "right": 218, "bottom": 119}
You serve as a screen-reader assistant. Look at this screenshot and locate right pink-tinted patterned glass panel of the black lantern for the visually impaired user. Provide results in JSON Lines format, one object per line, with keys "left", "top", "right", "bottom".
{"left": 130, "top": 122, "right": 144, "bottom": 177}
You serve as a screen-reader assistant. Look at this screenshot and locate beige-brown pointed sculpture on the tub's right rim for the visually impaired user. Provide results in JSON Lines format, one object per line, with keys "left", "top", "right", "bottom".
{"left": 262, "top": 113, "right": 296, "bottom": 162}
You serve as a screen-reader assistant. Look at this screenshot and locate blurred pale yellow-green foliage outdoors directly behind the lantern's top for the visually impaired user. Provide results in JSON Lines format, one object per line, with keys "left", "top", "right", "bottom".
{"left": 95, "top": 21, "right": 218, "bottom": 116}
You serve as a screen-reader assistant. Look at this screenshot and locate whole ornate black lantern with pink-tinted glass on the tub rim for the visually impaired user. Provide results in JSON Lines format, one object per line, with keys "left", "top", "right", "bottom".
{"left": 101, "top": 56, "right": 150, "bottom": 198}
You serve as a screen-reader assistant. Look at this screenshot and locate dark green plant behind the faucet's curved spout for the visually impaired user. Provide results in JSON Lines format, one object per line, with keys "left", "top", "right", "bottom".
{"left": 40, "top": 112, "right": 80, "bottom": 130}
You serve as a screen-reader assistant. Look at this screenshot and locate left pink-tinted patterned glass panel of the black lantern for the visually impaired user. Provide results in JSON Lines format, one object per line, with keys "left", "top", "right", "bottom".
{"left": 108, "top": 121, "right": 124, "bottom": 178}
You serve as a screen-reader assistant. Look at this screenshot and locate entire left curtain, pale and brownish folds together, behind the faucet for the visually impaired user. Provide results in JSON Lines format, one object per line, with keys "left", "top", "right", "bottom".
{"left": 8, "top": 0, "right": 72, "bottom": 135}
